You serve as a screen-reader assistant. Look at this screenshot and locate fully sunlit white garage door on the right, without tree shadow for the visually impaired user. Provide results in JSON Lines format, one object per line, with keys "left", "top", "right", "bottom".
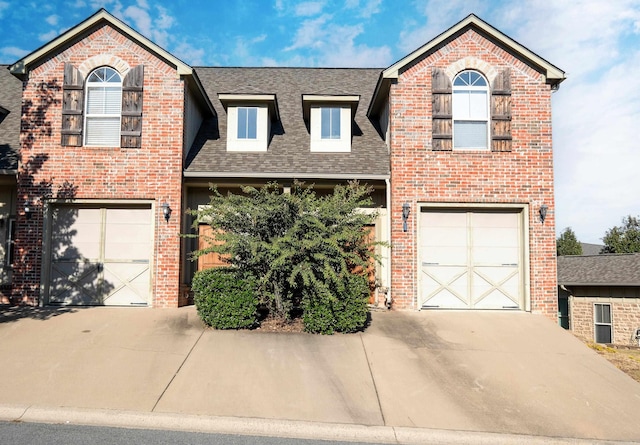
{"left": 419, "top": 209, "right": 524, "bottom": 309}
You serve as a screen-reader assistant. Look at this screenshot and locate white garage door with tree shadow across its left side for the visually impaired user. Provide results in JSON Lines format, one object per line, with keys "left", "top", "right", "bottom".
{"left": 47, "top": 206, "right": 152, "bottom": 306}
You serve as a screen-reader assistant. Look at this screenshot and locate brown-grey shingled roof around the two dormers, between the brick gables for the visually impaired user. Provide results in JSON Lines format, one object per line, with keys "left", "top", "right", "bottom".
{"left": 185, "top": 67, "right": 389, "bottom": 179}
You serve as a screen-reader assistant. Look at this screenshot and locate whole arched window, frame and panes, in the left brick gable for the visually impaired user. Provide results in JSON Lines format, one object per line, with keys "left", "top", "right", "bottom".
{"left": 84, "top": 66, "right": 122, "bottom": 147}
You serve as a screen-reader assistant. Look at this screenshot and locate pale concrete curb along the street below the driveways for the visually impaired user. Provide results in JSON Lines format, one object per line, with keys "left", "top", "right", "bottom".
{"left": 0, "top": 405, "right": 637, "bottom": 445}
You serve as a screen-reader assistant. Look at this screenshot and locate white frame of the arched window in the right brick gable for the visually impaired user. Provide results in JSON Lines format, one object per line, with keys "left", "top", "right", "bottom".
{"left": 452, "top": 70, "right": 491, "bottom": 150}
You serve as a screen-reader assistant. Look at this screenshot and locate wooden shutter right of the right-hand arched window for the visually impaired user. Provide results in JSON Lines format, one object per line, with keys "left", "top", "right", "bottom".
{"left": 491, "top": 68, "right": 511, "bottom": 151}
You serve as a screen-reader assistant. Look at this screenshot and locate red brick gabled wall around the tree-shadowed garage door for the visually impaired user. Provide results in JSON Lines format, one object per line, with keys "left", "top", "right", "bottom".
{"left": 13, "top": 26, "right": 185, "bottom": 307}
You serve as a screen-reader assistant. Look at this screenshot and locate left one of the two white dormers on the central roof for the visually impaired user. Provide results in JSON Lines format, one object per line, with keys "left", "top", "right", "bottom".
{"left": 218, "top": 94, "right": 279, "bottom": 151}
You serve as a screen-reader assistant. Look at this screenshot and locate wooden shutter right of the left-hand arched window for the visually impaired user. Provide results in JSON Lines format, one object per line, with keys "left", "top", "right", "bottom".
{"left": 120, "top": 65, "right": 144, "bottom": 148}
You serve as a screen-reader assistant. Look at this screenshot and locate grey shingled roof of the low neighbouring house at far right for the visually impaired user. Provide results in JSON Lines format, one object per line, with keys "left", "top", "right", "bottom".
{"left": 558, "top": 253, "right": 640, "bottom": 286}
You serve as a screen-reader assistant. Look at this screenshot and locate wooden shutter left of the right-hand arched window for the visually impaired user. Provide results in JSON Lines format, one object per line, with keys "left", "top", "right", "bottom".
{"left": 431, "top": 68, "right": 453, "bottom": 151}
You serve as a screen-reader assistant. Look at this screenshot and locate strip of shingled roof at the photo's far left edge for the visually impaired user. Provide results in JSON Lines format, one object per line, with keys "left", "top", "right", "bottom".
{"left": 0, "top": 65, "right": 22, "bottom": 174}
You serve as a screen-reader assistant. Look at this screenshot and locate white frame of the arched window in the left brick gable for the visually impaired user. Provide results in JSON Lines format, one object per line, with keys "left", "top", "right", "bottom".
{"left": 83, "top": 66, "right": 122, "bottom": 147}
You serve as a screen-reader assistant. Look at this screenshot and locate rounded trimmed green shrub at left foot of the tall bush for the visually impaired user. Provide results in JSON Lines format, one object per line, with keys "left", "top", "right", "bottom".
{"left": 192, "top": 268, "right": 258, "bottom": 329}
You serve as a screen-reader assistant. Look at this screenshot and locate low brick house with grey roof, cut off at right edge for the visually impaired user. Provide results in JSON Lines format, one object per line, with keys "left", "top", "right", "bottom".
{"left": 558, "top": 253, "right": 640, "bottom": 346}
